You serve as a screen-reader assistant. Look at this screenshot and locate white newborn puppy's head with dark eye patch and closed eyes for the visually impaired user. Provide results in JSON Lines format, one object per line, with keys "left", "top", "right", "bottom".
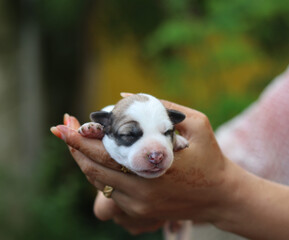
{"left": 91, "top": 94, "right": 185, "bottom": 178}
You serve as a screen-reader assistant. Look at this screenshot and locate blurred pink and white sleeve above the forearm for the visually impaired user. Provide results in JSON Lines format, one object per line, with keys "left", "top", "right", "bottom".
{"left": 216, "top": 65, "right": 289, "bottom": 185}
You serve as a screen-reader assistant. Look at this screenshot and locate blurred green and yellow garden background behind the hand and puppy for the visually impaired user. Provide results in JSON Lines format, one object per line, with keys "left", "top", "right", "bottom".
{"left": 0, "top": 0, "right": 289, "bottom": 240}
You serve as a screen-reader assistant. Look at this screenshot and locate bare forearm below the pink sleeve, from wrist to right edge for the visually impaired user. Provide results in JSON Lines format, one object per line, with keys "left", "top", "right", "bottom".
{"left": 215, "top": 159, "right": 289, "bottom": 240}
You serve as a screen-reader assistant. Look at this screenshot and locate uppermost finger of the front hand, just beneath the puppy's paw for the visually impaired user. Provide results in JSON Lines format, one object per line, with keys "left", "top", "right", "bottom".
{"left": 51, "top": 125, "right": 121, "bottom": 170}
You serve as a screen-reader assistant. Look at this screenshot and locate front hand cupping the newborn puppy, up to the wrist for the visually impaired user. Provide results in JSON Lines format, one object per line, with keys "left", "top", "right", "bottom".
{"left": 52, "top": 101, "right": 228, "bottom": 223}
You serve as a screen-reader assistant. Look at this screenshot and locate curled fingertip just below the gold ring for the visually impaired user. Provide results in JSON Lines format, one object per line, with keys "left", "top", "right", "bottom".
{"left": 93, "top": 192, "right": 122, "bottom": 221}
